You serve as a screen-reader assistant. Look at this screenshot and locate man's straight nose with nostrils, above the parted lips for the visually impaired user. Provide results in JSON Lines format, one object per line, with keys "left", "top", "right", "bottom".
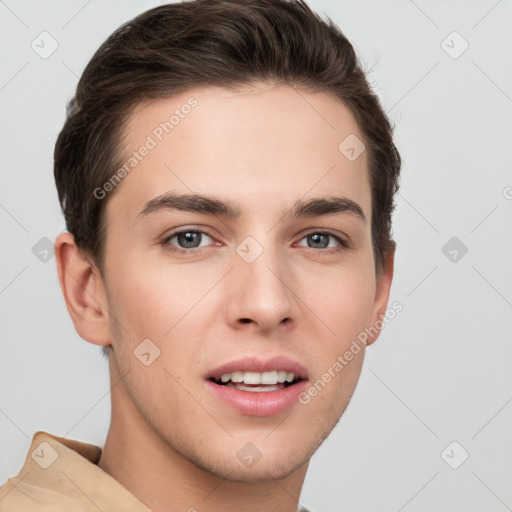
{"left": 227, "top": 241, "right": 296, "bottom": 333}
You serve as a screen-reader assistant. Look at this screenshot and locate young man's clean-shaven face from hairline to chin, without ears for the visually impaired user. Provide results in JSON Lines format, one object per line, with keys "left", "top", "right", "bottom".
{"left": 98, "top": 84, "right": 385, "bottom": 481}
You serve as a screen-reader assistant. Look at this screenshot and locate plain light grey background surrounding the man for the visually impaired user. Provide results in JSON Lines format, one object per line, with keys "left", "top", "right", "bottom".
{"left": 0, "top": 0, "right": 512, "bottom": 512}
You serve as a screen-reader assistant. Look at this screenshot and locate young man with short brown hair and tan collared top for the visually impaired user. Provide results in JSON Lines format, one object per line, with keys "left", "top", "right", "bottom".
{"left": 0, "top": 0, "right": 400, "bottom": 512}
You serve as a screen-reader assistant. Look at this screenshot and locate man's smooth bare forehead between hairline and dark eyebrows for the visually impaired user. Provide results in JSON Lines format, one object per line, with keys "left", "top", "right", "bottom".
{"left": 107, "top": 84, "right": 371, "bottom": 222}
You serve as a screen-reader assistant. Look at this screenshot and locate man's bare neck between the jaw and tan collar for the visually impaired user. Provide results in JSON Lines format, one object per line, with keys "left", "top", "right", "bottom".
{"left": 98, "top": 355, "right": 308, "bottom": 512}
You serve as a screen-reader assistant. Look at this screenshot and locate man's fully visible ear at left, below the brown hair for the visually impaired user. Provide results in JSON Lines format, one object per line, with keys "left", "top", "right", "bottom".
{"left": 55, "top": 232, "right": 110, "bottom": 346}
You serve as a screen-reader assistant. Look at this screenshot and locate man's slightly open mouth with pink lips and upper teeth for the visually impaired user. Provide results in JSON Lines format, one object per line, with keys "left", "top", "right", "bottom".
{"left": 205, "top": 357, "right": 308, "bottom": 416}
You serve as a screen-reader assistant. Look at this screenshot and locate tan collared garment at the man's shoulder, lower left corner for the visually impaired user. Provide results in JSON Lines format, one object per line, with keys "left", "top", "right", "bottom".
{"left": 0, "top": 431, "right": 307, "bottom": 512}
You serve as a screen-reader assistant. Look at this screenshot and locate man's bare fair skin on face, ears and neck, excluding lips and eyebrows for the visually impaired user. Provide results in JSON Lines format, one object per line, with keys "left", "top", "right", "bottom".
{"left": 55, "top": 83, "right": 394, "bottom": 512}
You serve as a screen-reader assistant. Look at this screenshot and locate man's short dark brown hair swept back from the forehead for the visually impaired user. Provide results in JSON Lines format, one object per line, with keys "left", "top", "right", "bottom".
{"left": 54, "top": 0, "right": 401, "bottom": 274}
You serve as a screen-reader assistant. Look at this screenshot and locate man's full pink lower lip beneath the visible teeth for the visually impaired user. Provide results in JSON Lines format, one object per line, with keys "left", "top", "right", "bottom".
{"left": 206, "top": 380, "right": 307, "bottom": 416}
